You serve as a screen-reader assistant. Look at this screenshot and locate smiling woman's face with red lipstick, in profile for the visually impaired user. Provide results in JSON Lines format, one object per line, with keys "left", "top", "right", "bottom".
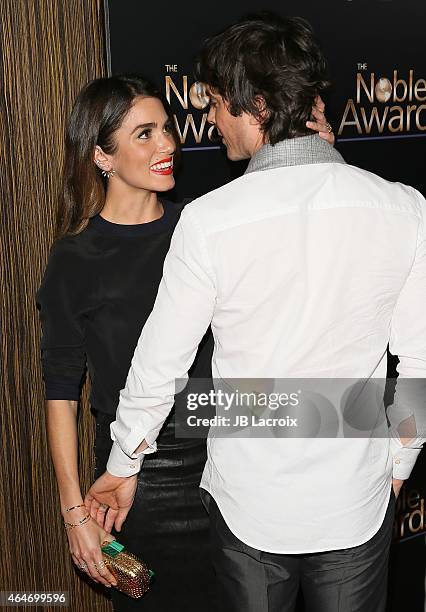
{"left": 106, "top": 97, "right": 176, "bottom": 191}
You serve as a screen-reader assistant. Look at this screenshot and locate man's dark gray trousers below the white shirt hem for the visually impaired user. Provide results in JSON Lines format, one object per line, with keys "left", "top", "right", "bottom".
{"left": 201, "top": 489, "right": 395, "bottom": 612}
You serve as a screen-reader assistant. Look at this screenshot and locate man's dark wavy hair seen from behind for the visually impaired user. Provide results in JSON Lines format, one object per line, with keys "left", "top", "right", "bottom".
{"left": 196, "top": 12, "right": 328, "bottom": 145}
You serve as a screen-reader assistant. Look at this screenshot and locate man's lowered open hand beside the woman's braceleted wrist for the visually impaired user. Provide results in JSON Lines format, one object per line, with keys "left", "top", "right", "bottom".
{"left": 84, "top": 472, "right": 137, "bottom": 533}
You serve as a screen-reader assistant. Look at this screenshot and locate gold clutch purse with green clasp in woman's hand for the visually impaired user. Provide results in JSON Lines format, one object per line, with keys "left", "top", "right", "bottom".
{"left": 101, "top": 540, "right": 154, "bottom": 599}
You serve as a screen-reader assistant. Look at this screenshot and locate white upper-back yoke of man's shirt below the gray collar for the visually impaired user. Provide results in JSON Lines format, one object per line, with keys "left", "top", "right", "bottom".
{"left": 184, "top": 163, "right": 426, "bottom": 234}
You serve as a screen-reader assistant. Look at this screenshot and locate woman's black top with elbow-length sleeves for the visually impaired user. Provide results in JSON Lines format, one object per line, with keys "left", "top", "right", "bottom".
{"left": 37, "top": 201, "right": 210, "bottom": 415}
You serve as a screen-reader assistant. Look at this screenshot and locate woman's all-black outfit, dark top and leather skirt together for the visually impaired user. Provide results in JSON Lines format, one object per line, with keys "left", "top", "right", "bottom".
{"left": 38, "top": 202, "right": 214, "bottom": 612}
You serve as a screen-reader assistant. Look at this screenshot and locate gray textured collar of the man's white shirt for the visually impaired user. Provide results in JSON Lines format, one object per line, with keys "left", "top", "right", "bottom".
{"left": 245, "top": 134, "right": 346, "bottom": 174}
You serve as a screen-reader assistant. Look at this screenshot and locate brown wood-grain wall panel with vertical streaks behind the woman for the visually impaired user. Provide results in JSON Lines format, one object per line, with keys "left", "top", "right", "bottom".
{"left": 0, "top": 0, "right": 111, "bottom": 612}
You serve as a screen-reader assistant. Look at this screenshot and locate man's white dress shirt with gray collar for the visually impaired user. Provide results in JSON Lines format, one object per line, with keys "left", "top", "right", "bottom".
{"left": 107, "top": 136, "right": 426, "bottom": 553}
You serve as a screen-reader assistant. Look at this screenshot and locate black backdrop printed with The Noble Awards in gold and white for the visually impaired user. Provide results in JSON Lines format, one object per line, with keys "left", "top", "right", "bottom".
{"left": 106, "top": 0, "right": 426, "bottom": 612}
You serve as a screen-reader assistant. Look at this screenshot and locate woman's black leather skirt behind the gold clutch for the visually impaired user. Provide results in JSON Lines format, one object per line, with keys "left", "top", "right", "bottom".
{"left": 95, "top": 412, "right": 214, "bottom": 612}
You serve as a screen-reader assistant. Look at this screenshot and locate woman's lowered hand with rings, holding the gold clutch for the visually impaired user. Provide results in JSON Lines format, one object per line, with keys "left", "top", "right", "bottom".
{"left": 67, "top": 513, "right": 117, "bottom": 587}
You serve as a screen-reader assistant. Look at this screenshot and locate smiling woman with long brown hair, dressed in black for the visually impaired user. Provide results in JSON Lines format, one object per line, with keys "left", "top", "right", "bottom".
{"left": 38, "top": 76, "right": 332, "bottom": 612}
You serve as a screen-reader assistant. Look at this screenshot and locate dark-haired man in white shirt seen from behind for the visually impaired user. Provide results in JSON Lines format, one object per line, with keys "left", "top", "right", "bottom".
{"left": 88, "top": 10, "right": 426, "bottom": 612}
